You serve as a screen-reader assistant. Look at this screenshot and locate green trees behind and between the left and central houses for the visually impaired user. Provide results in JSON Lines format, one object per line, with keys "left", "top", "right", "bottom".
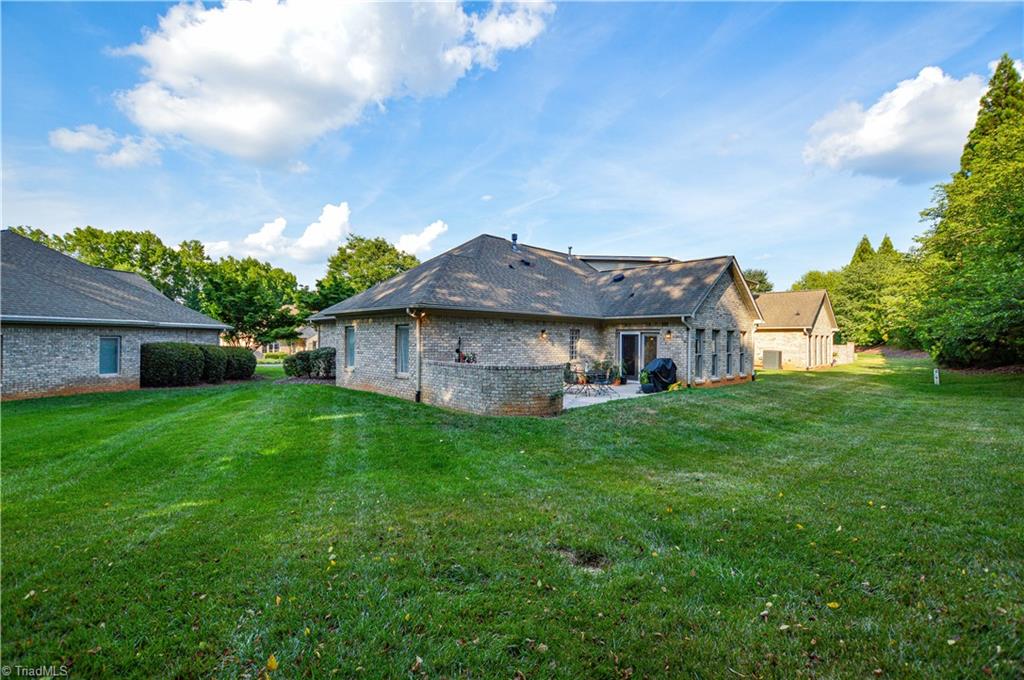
{"left": 11, "top": 226, "right": 420, "bottom": 347}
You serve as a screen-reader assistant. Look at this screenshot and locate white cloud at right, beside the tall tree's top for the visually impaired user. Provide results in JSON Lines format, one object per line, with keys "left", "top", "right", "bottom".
{"left": 804, "top": 67, "right": 986, "bottom": 181}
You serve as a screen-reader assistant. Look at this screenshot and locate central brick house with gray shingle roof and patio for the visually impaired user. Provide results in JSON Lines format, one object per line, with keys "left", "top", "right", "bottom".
{"left": 311, "top": 235, "right": 761, "bottom": 414}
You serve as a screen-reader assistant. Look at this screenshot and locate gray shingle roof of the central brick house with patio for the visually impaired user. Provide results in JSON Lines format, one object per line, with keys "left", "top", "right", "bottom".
{"left": 312, "top": 235, "right": 761, "bottom": 321}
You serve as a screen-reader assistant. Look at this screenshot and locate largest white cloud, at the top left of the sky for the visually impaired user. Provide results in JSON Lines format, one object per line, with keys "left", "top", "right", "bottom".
{"left": 105, "top": 0, "right": 554, "bottom": 160}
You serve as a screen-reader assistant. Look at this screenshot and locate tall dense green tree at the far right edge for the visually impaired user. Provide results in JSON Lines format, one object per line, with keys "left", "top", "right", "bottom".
{"left": 914, "top": 56, "right": 1024, "bottom": 366}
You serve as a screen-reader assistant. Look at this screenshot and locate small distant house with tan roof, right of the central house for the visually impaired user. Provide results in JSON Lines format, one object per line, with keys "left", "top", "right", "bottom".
{"left": 754, "top": 290, "right": 839, "bottom": 369}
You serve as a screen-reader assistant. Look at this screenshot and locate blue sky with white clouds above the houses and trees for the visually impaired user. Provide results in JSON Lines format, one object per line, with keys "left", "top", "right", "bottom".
{"left": 2, "top": 3, "right": 1024, "bottom": 287}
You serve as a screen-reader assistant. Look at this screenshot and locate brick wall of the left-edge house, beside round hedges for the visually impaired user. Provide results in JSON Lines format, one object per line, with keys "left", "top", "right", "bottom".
{"left": 2, "top": 324, "right": 219, "bottom": 399}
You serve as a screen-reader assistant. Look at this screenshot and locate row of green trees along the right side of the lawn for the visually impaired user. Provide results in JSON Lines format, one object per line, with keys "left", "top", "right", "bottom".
{"left": 745, "top": 54, "right": 1024, "bottom": 367}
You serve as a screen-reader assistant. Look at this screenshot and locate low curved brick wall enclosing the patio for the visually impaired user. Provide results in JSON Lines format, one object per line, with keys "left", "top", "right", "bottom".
{"left": 423, "top": 359, "right": 562, "bottom": 416}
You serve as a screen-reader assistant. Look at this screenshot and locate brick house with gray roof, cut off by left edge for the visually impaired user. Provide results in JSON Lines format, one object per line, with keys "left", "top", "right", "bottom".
{"left": 0, "top": 229, "right": 228, "bottom": 399}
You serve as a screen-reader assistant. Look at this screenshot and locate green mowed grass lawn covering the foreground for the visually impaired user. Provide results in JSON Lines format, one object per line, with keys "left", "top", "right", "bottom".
{"left": 2, "top": 356, "right": 1024, "bottom": 678}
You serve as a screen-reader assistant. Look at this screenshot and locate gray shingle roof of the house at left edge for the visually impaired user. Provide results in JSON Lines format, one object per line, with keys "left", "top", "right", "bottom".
{"left": 0, "top": 229, "right": 230, "bottom": 330}
